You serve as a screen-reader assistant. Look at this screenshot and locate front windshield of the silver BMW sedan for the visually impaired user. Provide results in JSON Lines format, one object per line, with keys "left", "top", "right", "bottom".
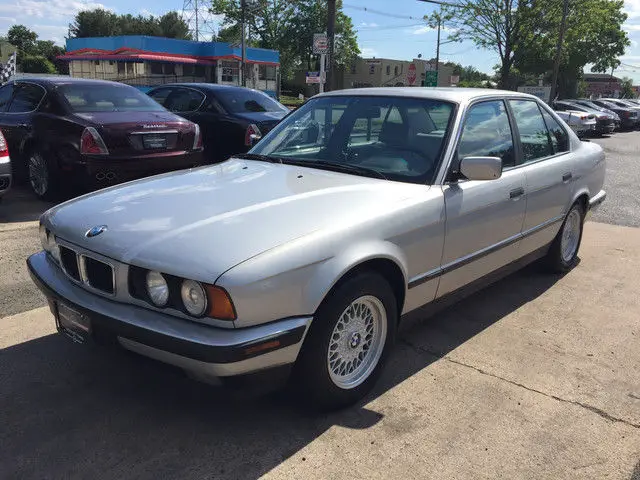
{"left": 251, "top": 95, "right": 454, "bottom": 183}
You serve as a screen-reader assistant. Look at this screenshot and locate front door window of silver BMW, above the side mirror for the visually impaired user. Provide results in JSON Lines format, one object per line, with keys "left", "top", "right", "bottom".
{"left": 458, "top": 100, "right": 516, "bottom": 167}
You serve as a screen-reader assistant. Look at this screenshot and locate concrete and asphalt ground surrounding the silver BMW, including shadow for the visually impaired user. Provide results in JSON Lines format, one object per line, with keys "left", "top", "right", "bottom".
{"left": 0, "top": 132, "right": 640, "bottom": 480}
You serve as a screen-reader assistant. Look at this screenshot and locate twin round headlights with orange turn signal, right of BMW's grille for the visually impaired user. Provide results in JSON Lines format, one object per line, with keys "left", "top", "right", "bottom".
{"left": 129, "top": 266, "right": 236, "bottom": 320}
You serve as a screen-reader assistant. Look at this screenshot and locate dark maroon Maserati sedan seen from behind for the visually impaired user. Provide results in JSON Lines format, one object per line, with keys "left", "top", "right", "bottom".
{"left": 0, "top": 77, "right": 202, "bottom": 198}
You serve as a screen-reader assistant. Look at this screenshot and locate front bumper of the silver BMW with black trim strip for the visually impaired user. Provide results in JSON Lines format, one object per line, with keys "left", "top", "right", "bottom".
{"left": 27, "top": 252, "right": 312, "bottom": 377}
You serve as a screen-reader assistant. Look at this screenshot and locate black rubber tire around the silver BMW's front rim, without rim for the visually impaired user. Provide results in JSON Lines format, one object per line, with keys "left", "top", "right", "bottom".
{"left": 293, "top": 272, "right": 398, "bottom": 411}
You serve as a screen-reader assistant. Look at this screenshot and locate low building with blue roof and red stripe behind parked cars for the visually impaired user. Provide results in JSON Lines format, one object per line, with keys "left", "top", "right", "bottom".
{"left": 59, "top": 35, "right": 280, "bottom": 95}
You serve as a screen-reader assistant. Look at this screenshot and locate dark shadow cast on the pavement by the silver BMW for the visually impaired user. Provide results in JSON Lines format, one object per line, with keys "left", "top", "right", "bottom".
{"left": 0, "top": 266, "right": 558, "bottom": 479}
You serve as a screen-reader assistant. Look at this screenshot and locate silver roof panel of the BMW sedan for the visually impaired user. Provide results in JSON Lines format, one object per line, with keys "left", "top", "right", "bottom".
{"left": 314, "top": 87, "right": 539, "bottom": 103}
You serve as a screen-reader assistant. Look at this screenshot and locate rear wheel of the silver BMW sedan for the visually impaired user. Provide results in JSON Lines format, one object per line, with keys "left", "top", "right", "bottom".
{"left": 546, "top": 203, "right": 585, "bottom": 273}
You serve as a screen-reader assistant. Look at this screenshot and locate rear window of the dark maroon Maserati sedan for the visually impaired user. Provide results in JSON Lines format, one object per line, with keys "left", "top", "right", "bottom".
{"left": 58, "top": 83, "right": 164, "bottom": 113}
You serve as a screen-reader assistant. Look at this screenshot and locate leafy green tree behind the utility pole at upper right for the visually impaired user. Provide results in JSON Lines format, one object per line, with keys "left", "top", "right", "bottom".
{"left": 515, "top": 0, "right": 630, "bottom": 97}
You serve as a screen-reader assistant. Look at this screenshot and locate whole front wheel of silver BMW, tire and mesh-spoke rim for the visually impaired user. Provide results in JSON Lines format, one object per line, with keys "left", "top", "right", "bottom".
{"left": 294, "top": 273, "right": 398, "bottom": 410}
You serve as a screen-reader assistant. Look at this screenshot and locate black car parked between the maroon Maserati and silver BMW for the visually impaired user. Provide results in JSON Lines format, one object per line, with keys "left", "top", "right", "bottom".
{"left": 147, "top": 83, "right": 289, "bottom": 163}
